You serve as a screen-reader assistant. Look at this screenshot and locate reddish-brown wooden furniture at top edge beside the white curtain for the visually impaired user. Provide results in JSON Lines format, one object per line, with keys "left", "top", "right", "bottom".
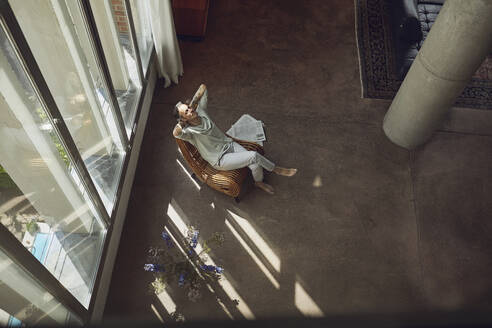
{"left": 172, "top": 0, "right": 210, "bottom": 38}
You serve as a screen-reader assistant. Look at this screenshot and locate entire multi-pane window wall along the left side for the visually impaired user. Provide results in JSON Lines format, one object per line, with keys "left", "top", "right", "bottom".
{"left": 0, "top": 0, "right": 152, "bottom": 326}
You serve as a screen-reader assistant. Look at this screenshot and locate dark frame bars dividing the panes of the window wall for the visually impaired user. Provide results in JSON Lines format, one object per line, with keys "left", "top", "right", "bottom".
{"left": 0, "top": 0, "right": 156, "bottom": 324}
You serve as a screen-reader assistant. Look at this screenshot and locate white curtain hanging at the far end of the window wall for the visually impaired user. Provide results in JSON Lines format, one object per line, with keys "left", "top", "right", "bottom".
{"left": 150, "top": 0, "right": 183, "bottom": 87}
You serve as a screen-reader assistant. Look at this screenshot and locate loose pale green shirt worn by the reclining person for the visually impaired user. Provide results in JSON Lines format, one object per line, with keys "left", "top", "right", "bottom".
{"left": 176, "top": 90, "right": 233, "bottom": 166}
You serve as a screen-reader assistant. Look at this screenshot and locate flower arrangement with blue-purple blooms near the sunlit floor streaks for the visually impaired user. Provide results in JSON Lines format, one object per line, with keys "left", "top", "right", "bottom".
{"left": 144, "top": 226, "right": 224, "bottom": 302}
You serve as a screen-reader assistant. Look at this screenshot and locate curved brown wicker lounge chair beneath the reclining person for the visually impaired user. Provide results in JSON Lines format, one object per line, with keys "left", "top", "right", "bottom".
{"left": 176, "top": 138, "right": 264, "bottom": 202}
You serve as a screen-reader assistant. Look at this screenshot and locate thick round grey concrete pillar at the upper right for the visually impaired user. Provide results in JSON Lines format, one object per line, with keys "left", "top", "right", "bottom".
{"left": 383, "top": 0, "right": 492, "bottom": 149}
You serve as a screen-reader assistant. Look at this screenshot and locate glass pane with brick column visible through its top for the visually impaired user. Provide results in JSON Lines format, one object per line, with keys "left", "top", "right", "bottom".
{"left": 90, "top": 0, "right": 142, "bottom": 136}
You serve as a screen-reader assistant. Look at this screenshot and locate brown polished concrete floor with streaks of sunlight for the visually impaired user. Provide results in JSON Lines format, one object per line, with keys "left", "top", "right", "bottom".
{"left": 105, "top": 0, "right": 492, "bottom": 321}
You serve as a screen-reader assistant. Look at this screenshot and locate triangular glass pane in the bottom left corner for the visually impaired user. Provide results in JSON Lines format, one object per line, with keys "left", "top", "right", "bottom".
{"left": 0, "top": 250, "right": 81, "bottom": 327}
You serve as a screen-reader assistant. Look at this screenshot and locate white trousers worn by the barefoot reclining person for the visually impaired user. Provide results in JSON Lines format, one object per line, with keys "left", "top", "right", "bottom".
{"left": 214, "top": 142, "right": 275, "bottom": 181}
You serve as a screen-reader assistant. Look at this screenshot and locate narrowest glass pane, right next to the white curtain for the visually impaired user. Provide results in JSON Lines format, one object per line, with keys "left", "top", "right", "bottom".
{"left": 130, "top": 0, "right": 153, "bottom": 74}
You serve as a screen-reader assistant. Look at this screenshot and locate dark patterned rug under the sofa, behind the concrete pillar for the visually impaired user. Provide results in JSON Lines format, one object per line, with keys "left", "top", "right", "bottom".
{"left": 355, "top": 0, "right": 492, "bottom": 110}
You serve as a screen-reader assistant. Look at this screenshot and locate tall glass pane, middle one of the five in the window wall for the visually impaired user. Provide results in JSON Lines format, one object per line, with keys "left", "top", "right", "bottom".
{"left": 10, "top": 0, "right": 125, "bottom": 214}
